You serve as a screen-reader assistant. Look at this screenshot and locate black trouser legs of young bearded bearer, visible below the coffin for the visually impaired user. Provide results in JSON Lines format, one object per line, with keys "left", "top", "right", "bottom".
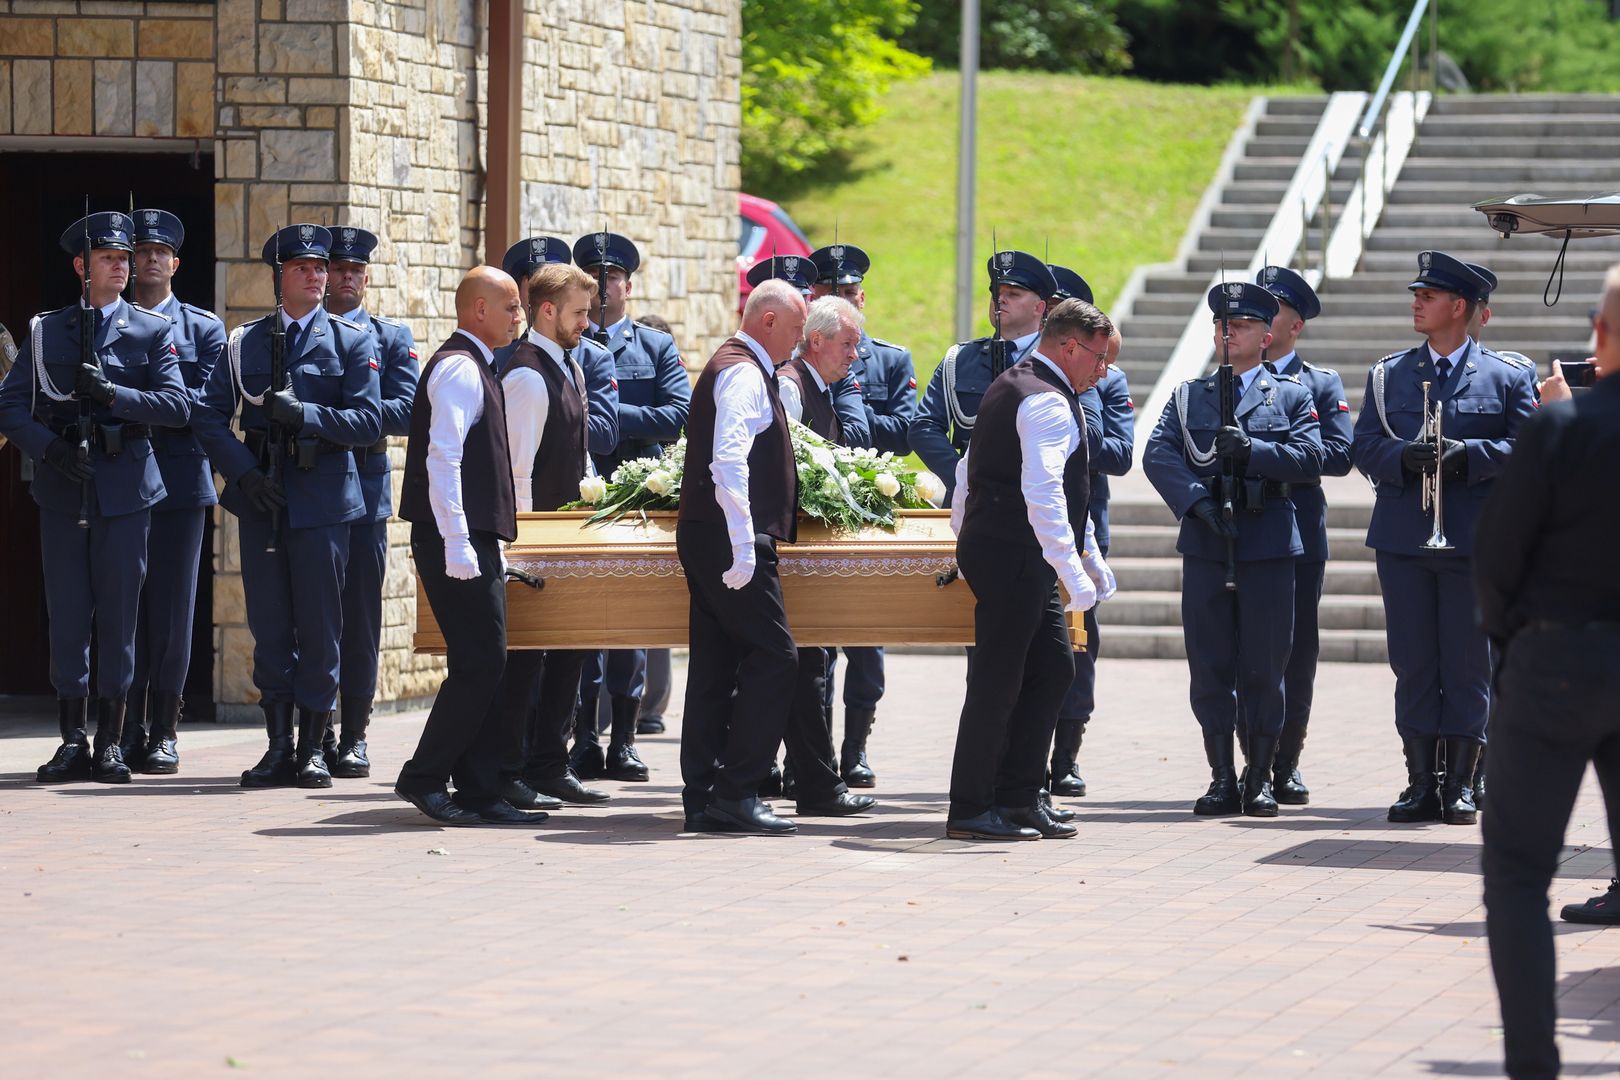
{"left": 496, "top": 649, "right": 591, "bottom": 784}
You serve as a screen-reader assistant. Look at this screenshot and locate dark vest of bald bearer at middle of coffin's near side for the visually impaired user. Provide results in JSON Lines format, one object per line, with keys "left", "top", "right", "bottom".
{"left": 680, "top": 337, "right": 799, "bottom": 542}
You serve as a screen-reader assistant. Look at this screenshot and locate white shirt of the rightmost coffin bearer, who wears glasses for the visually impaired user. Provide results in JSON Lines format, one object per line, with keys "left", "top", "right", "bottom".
{"left": 951, "top": 350, "right": 1085, "bottom": 596}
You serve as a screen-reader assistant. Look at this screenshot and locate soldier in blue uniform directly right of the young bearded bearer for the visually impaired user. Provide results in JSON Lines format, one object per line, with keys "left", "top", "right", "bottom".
{"left": 572, "top": 232, "right": 692, "bottom": 780}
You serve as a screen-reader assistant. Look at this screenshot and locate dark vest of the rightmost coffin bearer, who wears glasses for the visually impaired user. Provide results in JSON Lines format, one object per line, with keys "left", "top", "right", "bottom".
{"left": 961, "top": 353, "right": 1090, "bottom": 551}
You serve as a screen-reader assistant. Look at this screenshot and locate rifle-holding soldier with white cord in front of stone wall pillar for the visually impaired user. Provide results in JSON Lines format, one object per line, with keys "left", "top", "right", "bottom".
{"left": 191, "top": 225, "right": 382, "bottom": 787}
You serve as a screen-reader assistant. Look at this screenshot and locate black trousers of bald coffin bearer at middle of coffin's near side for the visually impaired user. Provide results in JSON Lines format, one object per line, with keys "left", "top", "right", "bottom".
{"left": 676, "top": 521, "right": 799, "bottom": 814}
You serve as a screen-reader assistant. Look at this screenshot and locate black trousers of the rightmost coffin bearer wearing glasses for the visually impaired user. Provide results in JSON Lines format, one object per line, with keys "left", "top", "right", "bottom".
{"left": 951, "top": 539, "right": 1074, "bottom": 819}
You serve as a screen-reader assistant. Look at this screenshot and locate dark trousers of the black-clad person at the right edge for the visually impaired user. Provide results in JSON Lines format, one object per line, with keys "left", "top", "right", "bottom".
{"left": 1484, "top": 627, "right": 1620, "bottom": 1077}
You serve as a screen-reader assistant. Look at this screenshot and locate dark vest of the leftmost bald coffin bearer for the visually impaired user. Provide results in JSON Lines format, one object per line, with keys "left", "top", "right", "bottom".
{"left": 400, "top": 330, "right": 517, "bottom": 541}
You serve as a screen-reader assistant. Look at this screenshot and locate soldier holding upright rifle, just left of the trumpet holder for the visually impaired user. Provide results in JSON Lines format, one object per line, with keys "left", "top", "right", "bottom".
{"left": 1142, "top": 282, "right": 1322, "bottom": 818}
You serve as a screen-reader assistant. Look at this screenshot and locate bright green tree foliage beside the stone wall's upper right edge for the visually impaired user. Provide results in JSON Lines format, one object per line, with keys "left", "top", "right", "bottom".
{"left": 742, "top": 0, "right": 928, "bottom": 191}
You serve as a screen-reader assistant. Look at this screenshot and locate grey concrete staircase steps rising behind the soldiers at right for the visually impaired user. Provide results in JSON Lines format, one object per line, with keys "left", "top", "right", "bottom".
{"left": 1098, "top": 96, "right": 1620, "bottom": 662}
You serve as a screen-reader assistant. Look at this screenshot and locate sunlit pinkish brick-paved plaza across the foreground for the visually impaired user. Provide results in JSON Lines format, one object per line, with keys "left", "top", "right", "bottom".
{"left": 0, "top": 656, "right": 1620, "bottom": 1077}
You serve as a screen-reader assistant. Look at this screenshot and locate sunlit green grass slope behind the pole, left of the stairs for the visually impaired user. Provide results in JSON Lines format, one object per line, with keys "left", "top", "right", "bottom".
{"left": 771, "top": 71, "right": 1264, "bottom": 385}
